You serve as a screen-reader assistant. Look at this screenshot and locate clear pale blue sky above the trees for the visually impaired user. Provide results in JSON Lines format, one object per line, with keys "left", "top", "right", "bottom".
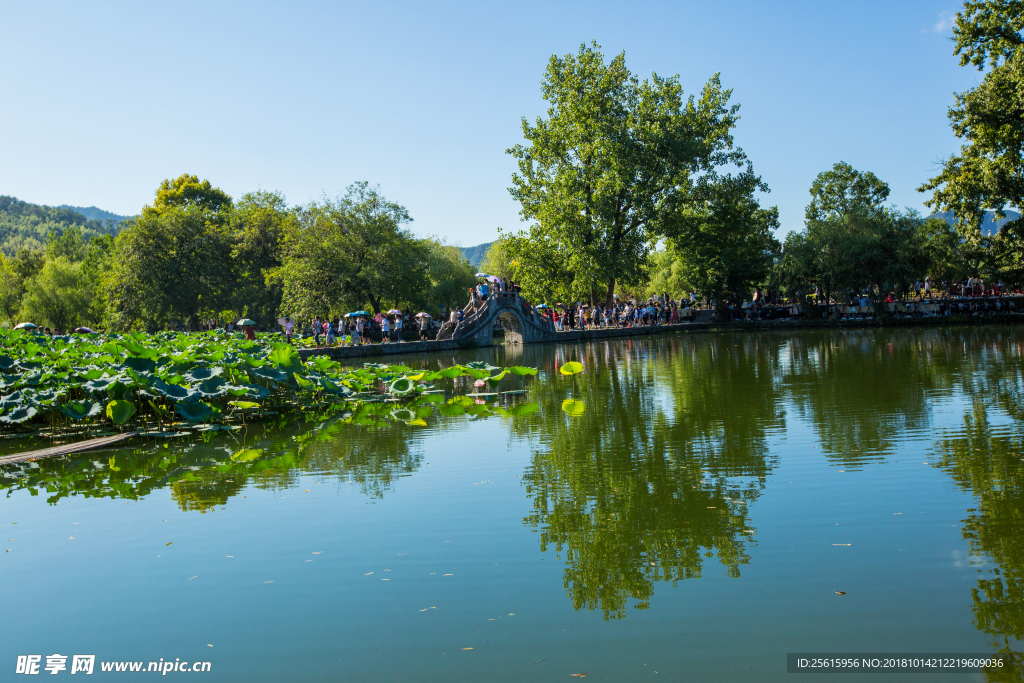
{"left": 0, "top": 0, "right": 979, "bottom": 246}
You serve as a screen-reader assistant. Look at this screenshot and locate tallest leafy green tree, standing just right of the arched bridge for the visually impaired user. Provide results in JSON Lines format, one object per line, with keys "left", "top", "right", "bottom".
{"left": 505, "top": 43, "right": 745, "bottom": 303}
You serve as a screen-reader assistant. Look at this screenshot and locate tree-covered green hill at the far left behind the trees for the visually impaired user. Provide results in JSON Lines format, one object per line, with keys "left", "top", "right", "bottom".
{"left": 0, "top": 195, "right": 119, "bottom": 256}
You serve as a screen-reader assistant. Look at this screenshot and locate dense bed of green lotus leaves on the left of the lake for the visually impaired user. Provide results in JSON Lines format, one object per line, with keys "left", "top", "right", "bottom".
{"left": 0, "top": 330, "right": 544, "bottom": 438}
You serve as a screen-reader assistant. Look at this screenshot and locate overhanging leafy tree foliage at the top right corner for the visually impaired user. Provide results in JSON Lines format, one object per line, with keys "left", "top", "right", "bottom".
{"left": 920, "top": 0, "right": 1024, "bottom": 232}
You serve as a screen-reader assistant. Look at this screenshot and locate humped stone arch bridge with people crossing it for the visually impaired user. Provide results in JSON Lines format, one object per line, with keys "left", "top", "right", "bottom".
{"left": 437, "top": 292, "right": 555, "bottom": 346}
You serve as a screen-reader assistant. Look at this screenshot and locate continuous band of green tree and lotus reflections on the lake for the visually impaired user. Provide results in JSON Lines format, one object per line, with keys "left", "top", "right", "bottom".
{"left": 6, "top": 328, "right": 1024, "bottom": 663}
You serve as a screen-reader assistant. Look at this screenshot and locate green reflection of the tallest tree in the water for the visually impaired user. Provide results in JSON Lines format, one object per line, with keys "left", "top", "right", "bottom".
{"left": 513, "top": 336, "right": 782, "bottom": 618}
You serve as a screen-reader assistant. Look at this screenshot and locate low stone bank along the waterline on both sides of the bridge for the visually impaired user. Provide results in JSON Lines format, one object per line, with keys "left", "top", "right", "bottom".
{"left": 298, "top": 313, "right": 1024, "bottom": 360}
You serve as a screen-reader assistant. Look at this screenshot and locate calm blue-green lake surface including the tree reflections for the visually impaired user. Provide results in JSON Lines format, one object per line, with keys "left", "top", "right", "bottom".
{"left": 0, "top": 328, "right": 1024, "bottom": 681}
